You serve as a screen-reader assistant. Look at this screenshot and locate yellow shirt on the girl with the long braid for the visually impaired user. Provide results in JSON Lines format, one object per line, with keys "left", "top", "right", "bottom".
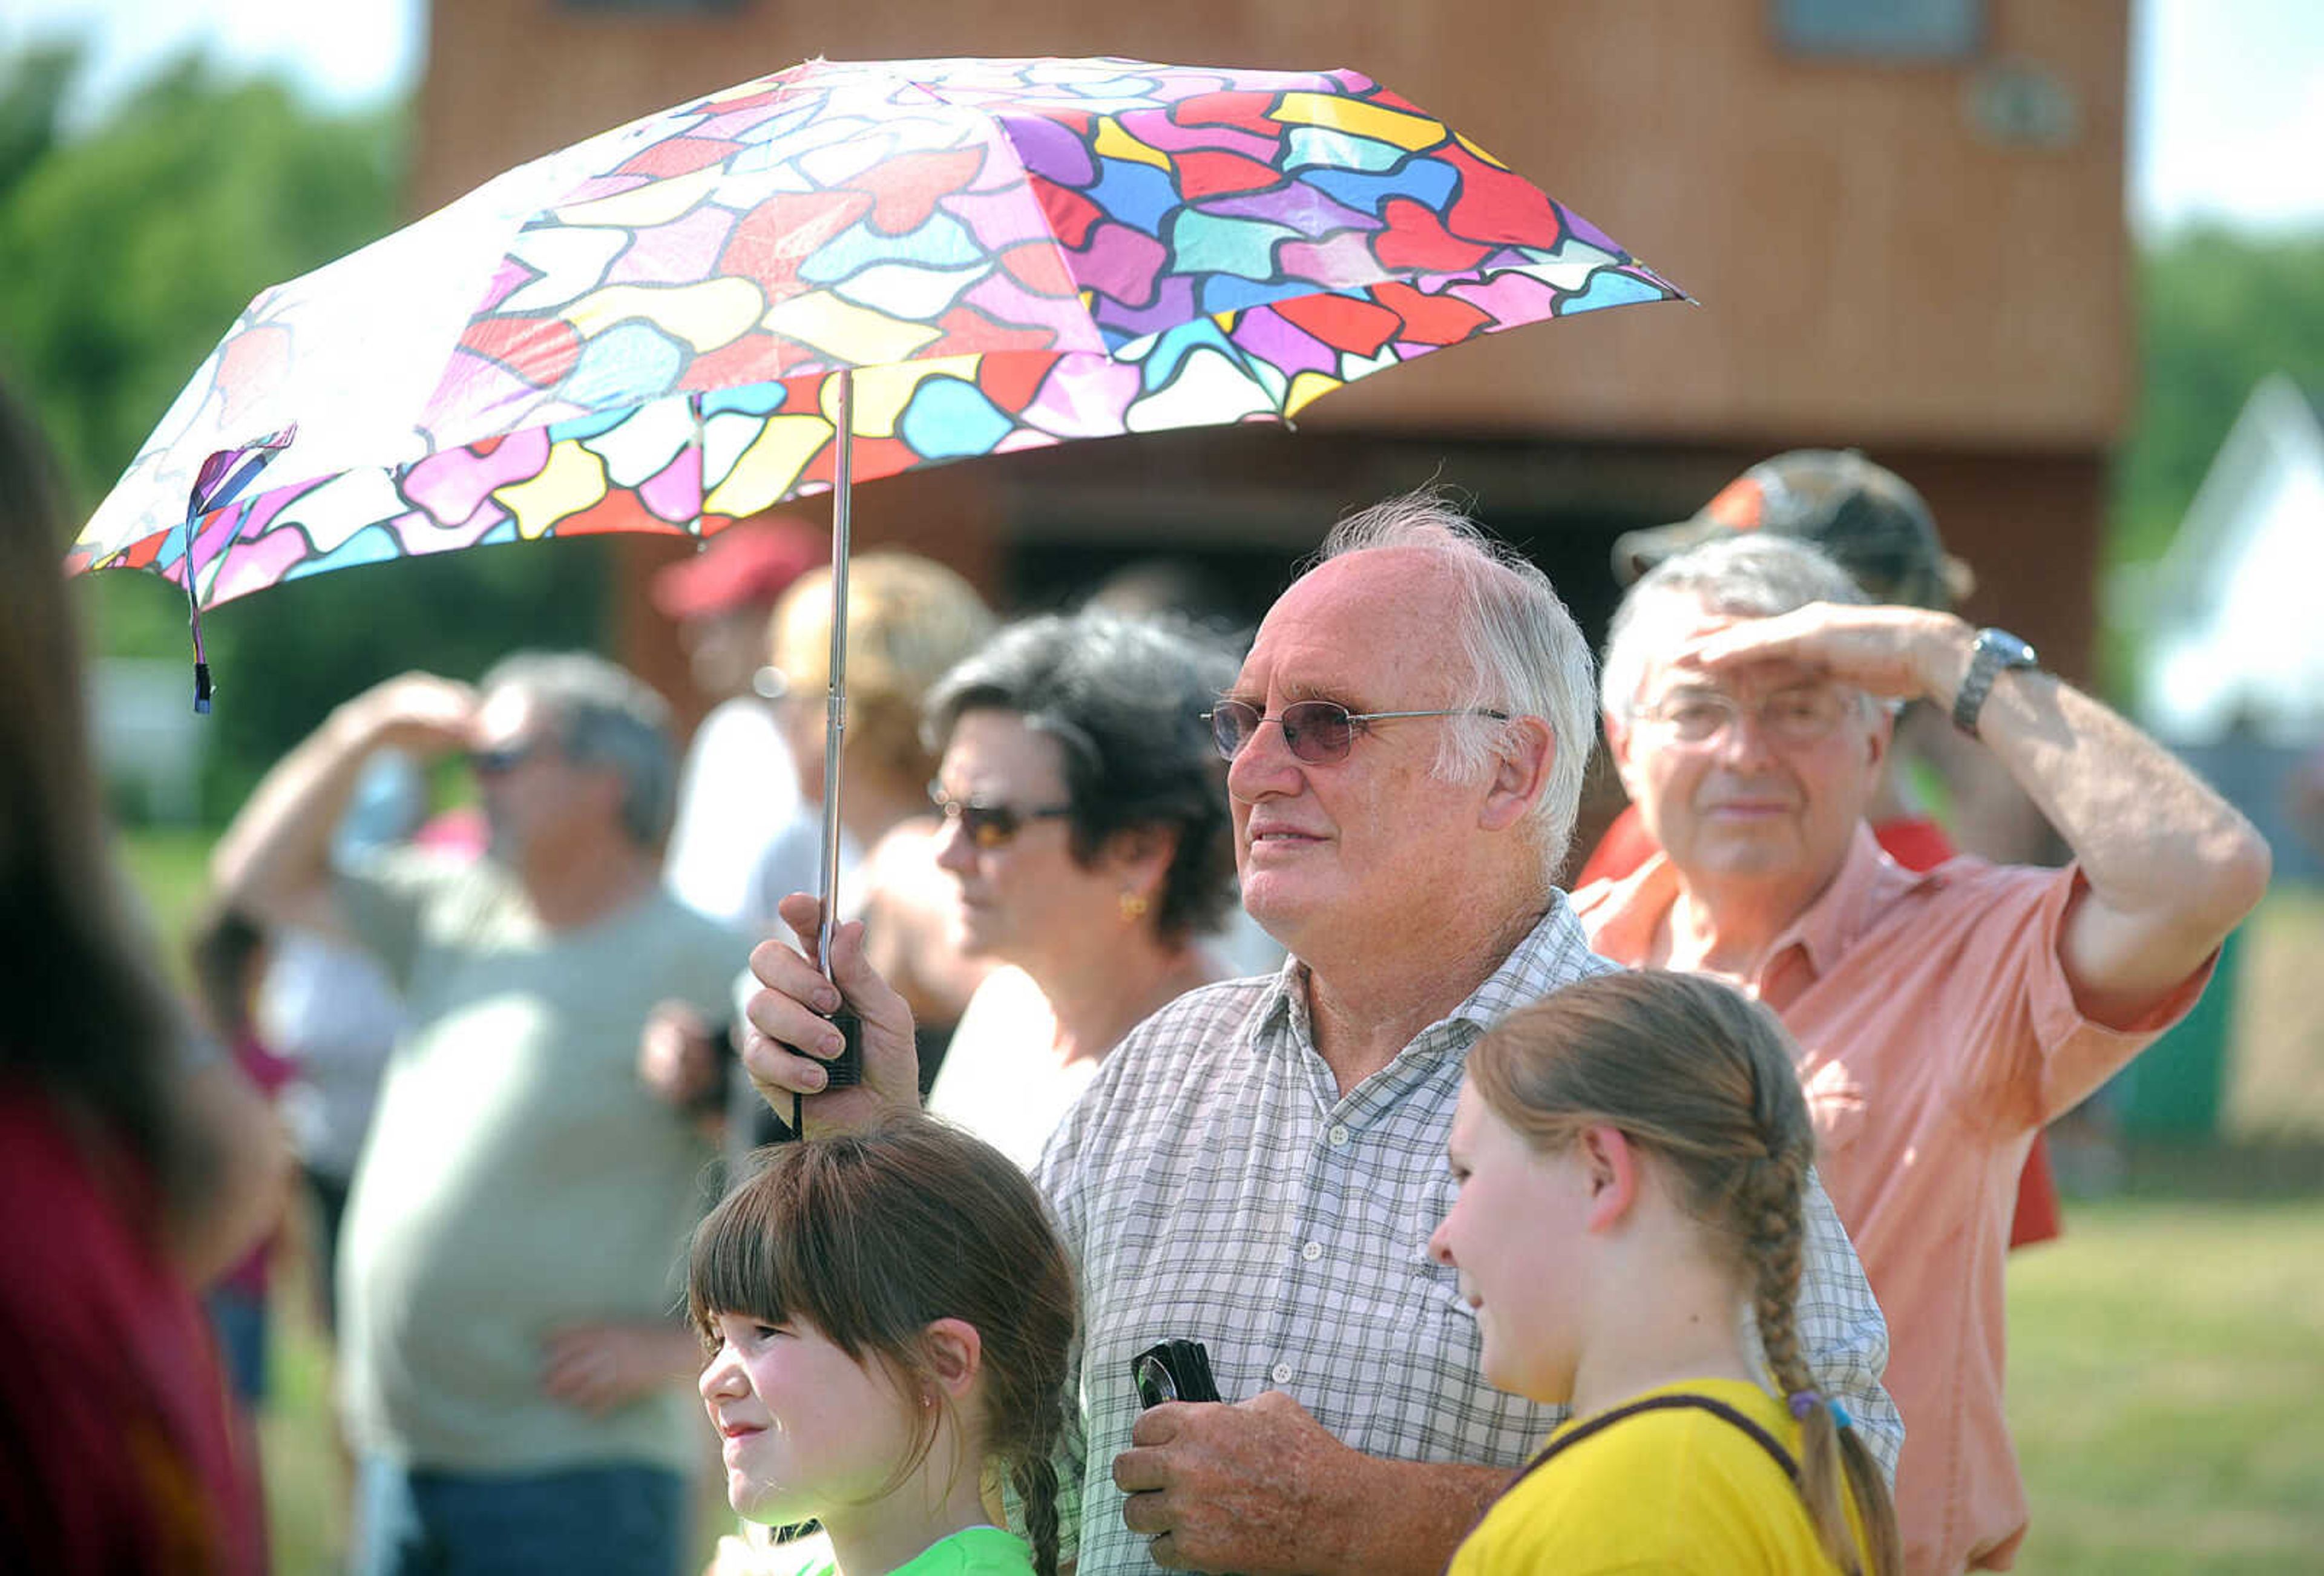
{"left": 1448, "top": 1379, "right": 1864, "bottom": 1576}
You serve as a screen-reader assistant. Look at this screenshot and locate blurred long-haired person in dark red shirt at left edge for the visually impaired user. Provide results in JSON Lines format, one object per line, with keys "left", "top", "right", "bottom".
{"left": 0, "top": 386, "right": 288, "bottom": 1576}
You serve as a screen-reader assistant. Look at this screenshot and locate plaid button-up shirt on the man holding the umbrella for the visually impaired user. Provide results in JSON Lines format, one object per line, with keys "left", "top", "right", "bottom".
{"left": 1034, "top": 895, "right": 1903, "bottom": 1576}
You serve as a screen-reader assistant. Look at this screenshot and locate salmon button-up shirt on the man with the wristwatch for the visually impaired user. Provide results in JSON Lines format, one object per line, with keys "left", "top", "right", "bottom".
{"left": 1574, "top": 827, "right": 2213, "bottom": 1574}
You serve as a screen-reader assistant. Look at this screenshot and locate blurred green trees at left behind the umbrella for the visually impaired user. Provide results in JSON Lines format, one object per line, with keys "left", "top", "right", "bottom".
{"left": 0, "top": 44, "right": 611, "bottom": 816}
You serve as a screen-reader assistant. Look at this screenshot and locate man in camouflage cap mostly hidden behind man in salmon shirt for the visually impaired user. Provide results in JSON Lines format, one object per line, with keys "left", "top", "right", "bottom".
{"left": 1571, "top": 448, "right": 2064, "bottom": 1248}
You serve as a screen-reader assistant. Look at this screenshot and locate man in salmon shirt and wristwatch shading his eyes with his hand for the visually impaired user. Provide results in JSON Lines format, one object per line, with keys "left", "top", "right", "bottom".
{"left": 1574, "top": 533, "right": 2268, "bottom": 1574}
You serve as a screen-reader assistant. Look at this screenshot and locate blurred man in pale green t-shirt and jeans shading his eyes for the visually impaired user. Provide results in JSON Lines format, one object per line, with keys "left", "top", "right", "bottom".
{"left": 211, "top": 653, "right": 741, "bottom": 1576}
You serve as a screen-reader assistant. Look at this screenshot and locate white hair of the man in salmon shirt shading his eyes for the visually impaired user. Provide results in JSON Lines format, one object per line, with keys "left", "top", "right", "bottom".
{"left": 1599, "top": 533, "right": 1871, "bottom": 718}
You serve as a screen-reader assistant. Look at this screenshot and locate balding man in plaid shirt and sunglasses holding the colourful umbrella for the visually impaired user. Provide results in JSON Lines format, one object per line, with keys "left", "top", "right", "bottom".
{"left": 744, "top": 497, "right": 1899, "bottom": 1576}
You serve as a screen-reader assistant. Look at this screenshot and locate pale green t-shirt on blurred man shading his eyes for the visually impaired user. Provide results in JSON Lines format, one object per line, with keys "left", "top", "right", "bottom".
{"left": 340, "top": 853, "right": 746, "bottom": 1471}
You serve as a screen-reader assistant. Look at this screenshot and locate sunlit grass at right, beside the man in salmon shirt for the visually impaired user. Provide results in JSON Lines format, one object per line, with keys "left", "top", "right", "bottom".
{"left": 2008, "top": 1199, "right": 2324, "bottom": 1576}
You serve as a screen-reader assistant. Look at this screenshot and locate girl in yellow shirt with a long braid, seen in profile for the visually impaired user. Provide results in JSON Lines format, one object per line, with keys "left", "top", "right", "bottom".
{"left": 1430, "top": 971, "right": 1901, "bottom": 1576}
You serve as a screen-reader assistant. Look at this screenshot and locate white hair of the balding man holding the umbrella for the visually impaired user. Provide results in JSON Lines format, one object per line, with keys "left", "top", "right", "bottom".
{"left": 1311, "top": 488, "right": 1597, "bottom": 881}
